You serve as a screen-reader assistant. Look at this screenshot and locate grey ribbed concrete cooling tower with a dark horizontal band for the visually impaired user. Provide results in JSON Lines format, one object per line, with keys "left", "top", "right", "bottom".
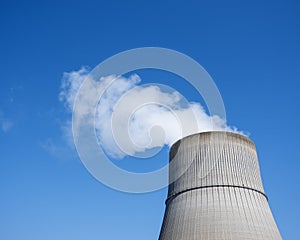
{"left": 159, "top": 132, "right": 281, "bottom": 240}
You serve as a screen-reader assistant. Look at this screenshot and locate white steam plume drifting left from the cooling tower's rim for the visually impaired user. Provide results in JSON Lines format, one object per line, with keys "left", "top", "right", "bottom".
{"left": 59, "top": 67, "right": 243, "bottom": 158}
